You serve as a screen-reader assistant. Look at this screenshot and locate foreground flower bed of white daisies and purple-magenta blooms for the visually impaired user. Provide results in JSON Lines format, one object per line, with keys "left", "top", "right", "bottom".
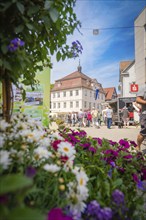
{"left": 0, "top": 115, "right": 146, "bottom": 220}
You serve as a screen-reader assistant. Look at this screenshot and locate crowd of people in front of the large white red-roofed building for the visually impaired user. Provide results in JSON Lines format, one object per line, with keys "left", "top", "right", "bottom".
{"left": 66, "top": 106, "right": 113, "bottom": 129}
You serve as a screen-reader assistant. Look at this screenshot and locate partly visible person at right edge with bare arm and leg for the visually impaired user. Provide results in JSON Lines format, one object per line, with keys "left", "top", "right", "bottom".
{"left": 136, "top": 85, "right": 146, "bottom": 150}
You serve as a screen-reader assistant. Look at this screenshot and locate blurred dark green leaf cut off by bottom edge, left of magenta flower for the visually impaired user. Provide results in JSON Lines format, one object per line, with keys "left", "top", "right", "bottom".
{"left": 7, "top": 208, "right": 45, "bottom": 220}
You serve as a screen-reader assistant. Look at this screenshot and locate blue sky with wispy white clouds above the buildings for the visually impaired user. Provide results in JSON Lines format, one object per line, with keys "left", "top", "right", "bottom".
{"left": 51, "top": 0, "right": 146, "bottom": 92}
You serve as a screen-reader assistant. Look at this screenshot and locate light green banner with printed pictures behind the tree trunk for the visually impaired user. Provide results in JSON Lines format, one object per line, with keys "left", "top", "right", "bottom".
{"left": 13, "top": 67, "right": 50, "bottom": 125}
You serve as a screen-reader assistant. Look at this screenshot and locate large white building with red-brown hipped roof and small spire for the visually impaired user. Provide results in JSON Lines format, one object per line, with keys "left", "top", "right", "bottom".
{"left": 50, "top": 66, "right": 105, "bottom": 113}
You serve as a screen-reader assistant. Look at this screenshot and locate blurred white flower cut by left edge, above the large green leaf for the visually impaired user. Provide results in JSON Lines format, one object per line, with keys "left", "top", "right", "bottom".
{"left": 0, "top": 150, "right": 12, "bottom": 169}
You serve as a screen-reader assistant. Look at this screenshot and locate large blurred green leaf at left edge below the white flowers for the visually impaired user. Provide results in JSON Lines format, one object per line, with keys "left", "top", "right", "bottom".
{"left": 0, "top": 174, "right": 32, "bottom": 194}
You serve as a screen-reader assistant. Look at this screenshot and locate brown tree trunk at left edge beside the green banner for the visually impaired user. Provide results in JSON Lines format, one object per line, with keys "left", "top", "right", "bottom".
{"left": 2, "top": 77, "right": 12, "bottom": 122}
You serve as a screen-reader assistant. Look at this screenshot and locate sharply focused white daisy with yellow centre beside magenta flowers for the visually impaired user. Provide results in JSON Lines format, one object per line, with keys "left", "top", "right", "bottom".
{"left": 58, "top": 141, "right": 76, "bottom": 158}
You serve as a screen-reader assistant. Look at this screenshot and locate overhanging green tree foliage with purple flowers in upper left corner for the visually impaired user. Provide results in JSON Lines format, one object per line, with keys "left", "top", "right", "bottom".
{"left": 0, "top": 0, "right": 82, "bottom": 88}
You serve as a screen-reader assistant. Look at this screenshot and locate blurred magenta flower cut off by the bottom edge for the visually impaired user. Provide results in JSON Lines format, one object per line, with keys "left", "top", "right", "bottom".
{"left": 47, "top": 208, "right": 73, "bottom": 220}
